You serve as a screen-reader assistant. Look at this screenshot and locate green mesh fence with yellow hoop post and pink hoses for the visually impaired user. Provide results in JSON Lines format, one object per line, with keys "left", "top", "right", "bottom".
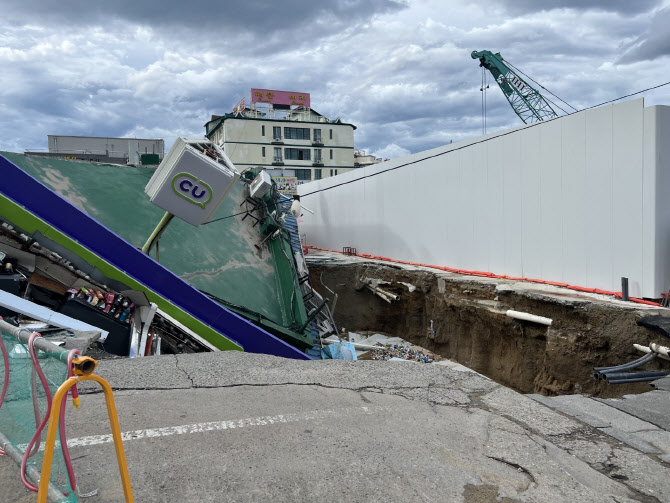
{"left": 0, "top": 318, "right": 133, "bottom": 503}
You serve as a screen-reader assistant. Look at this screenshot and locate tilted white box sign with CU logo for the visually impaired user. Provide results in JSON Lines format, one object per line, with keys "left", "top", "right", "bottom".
{"left": 144, "top": 138, "right": 240, "bottom": 227}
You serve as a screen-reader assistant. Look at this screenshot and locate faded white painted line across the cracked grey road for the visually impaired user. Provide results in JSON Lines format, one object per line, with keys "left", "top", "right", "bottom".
{"left": 62, "top": 406, "right": 388, "bottom": 448}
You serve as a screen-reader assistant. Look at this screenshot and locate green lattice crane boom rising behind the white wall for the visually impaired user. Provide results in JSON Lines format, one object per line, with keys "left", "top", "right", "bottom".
{"left": 472, "top": 51, "right": 558, "bottom": 124}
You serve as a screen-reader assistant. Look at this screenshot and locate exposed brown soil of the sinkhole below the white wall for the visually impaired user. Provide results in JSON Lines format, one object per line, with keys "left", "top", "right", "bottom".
{"left": 310, "top": 262, "right": 670, "bottom": 397}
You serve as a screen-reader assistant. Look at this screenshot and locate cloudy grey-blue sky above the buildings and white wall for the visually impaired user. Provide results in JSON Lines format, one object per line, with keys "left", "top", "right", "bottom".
{"left": 0, "top": 0, "right": 670, "bottom": 157}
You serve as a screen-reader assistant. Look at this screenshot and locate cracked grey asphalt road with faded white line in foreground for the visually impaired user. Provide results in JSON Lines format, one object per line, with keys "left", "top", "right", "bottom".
{"left": 0, "top": 351, "right": 670, "bottom": 503}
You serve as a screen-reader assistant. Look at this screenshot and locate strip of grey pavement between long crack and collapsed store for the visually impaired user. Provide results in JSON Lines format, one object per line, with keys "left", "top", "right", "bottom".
{"left": 82, "top": 351, "right": 499, "bottom": 400}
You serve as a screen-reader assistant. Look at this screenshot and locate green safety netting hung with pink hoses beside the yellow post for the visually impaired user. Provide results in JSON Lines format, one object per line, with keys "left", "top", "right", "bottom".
{"left": 0, "top": 332, "right": 79, "bottom": 502}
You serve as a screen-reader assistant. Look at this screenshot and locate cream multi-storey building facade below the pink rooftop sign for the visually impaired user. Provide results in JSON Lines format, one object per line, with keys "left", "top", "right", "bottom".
{"left": 205, "top": 97, "right": 356, "bottom": 183}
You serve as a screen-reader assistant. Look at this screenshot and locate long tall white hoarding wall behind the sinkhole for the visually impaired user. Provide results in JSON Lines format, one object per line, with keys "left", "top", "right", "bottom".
{"left": 299, "top": 99, "right": 670, "bottom": 298}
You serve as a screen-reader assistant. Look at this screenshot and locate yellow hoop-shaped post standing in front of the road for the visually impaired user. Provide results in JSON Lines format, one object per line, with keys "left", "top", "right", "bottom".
{"left": 37, "top": 374, "right": 135, "bottom": 503}
